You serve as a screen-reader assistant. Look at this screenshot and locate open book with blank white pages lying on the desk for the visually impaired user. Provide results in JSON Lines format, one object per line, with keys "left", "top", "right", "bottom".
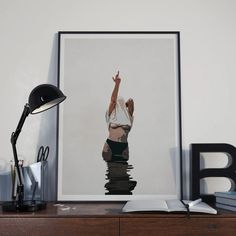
{"left": 122, "top": 199, "right": 217, "bottom": 214}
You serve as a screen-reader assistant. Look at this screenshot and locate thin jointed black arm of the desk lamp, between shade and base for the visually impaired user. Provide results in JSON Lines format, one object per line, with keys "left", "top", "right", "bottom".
{"left": 11, "top": 104, "right": 30, "bottom": 202}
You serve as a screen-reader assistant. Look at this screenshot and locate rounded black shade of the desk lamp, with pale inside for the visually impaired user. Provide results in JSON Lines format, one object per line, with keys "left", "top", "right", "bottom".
{"left": 28, "top": 84, "right": 66, "bottom": 114}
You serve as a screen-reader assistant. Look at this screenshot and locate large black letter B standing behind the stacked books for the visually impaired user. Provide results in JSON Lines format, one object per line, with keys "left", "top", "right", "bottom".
{"left": 190, "top": 143, "right": 236, "bottom": 202}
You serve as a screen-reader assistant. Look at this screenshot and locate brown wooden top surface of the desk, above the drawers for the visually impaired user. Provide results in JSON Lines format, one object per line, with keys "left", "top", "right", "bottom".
{"left": 0, "top": 202, "right": 236, "bottom": 218}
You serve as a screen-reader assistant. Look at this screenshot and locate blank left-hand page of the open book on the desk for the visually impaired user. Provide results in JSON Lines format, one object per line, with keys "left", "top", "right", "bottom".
{"left": 122, "top": 199, "right": 169, "bottom": 212}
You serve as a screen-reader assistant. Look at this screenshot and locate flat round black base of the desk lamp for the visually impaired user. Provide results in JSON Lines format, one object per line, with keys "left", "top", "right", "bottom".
{"left": 2, "top": 200, "right": 47, "bottom": 212}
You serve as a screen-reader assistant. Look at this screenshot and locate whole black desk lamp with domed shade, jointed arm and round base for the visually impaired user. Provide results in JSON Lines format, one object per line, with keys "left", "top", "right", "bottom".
{"left": 2, "top": 84, "right": 66, "bottom": 211}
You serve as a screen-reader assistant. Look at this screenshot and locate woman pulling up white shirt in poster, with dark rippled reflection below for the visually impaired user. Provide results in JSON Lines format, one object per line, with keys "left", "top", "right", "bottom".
{"left": 102, "top": 71, "right": 137, "bottom": 194}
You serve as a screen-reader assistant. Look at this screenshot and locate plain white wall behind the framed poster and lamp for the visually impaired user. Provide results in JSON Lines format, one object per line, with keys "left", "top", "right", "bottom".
{"left": 0, "top": 0, "right": 236, "bottom": 199}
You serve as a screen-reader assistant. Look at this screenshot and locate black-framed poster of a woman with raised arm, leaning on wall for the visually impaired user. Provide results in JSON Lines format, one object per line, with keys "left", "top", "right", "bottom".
{"left": 58, "top": 32, "right": 182, "bottom": 201}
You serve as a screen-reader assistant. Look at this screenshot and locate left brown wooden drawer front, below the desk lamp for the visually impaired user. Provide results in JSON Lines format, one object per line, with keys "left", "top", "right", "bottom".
{"left": 0, "top": 217, "right": 119, "bottom": 236}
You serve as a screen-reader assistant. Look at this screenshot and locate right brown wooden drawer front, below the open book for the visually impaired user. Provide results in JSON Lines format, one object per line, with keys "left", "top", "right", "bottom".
{"left": 120, "top": 216, "right": 236, "bottom": 236}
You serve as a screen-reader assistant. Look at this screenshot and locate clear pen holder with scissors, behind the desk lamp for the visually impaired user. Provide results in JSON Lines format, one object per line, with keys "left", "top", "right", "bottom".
{"left": 23, "top": 161, "right": 48, "bottom": 201}
